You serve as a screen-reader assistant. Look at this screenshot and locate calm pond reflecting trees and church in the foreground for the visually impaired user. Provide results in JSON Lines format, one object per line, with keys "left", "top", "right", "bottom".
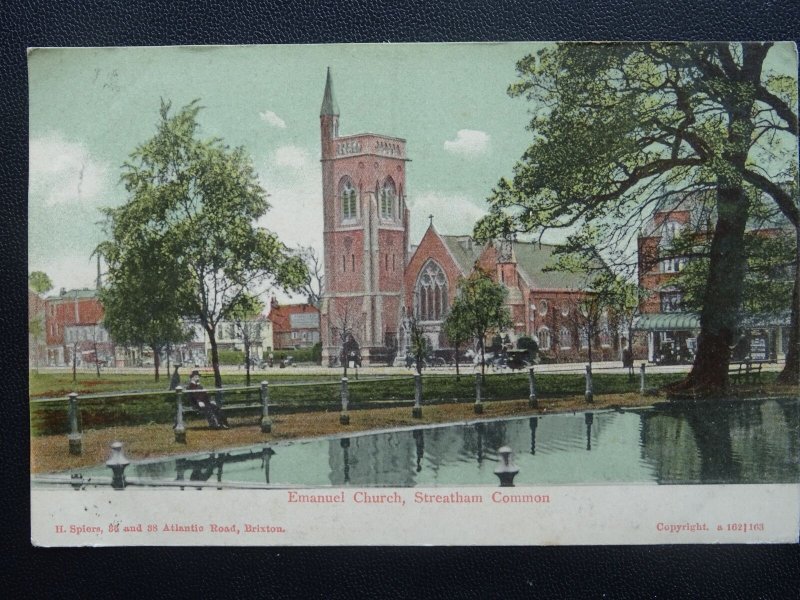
{"left": 73, "top": 399, "right": 800, "bottom": 487}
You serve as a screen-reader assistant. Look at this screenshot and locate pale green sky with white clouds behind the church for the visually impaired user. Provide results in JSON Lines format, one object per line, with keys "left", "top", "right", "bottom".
{"left": 28, "top": 43, "right": 796, "bottom": 298}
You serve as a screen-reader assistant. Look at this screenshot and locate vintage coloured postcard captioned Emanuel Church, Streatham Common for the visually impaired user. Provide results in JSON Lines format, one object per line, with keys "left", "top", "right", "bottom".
{"left": 28, "top": 42, "right": 800, "bottom": 546}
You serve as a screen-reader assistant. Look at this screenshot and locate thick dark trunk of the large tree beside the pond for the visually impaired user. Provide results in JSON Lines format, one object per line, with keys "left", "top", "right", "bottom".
{"left": 686, "top": 186, "right": 747, "bottom": 396}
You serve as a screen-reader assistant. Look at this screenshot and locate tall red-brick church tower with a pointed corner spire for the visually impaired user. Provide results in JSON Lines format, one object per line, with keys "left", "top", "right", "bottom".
{"left": 320, "top": 68, "right": 409, "bottom": 364}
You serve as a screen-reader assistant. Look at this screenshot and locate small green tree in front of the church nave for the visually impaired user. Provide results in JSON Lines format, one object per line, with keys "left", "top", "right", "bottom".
{"left": 457, "top": 267, "right": 511, "bottom": 374}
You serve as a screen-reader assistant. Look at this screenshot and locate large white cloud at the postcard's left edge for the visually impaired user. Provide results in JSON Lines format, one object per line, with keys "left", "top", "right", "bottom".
{"left": 30, "top": 134, "right": 112, "bottom": 206}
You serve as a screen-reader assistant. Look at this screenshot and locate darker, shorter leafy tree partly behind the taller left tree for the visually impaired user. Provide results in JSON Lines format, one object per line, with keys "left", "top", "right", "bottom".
{"left": 99, "top": 237, "right": 193, "bottom": 381}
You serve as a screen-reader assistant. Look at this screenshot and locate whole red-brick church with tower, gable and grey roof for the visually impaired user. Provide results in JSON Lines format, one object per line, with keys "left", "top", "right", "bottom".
{"left": 320, "top": 69, "right": 611, "bottom": 364}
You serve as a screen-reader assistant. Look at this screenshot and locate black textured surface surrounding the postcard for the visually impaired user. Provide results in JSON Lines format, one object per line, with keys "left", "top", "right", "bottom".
{"left": 0, "top": 0, "right": 800, "bottom": 598}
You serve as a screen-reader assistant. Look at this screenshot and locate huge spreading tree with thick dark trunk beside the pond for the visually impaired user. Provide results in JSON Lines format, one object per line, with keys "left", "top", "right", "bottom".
{"left": 476, "top": 43, "right": 800, "bottom": 395}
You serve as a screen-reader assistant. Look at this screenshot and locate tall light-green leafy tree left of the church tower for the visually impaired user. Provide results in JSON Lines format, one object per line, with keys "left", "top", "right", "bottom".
{"left": 104, "top": 100, "right": 307, "bottom": 387}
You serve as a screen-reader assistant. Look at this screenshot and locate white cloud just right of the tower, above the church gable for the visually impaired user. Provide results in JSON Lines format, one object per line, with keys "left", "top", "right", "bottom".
{"left": 408, "top": 191, "right": 486, "bottom": 244}
